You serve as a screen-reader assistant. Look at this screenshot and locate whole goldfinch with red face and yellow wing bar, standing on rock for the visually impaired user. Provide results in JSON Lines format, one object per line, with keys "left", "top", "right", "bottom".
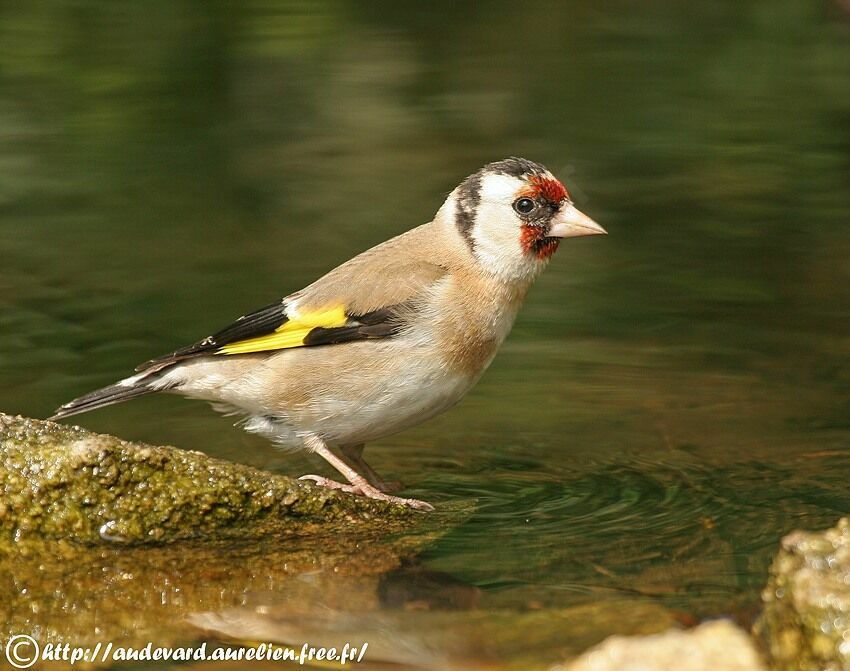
{"left": 50, "top": 157, "right": 606, "bottom": 511}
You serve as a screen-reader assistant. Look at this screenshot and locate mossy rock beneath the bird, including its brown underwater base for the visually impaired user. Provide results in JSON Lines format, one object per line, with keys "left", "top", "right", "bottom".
{"left": 0, "top": 414, "right": 468, "bottom": 646}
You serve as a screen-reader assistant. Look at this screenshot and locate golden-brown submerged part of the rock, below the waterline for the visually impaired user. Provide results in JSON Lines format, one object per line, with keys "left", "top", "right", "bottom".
{"left": 0, "top": 525, "right": 426, "bottom": 646}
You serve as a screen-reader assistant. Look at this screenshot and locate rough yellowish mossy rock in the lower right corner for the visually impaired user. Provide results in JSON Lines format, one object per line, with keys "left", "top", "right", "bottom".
{"left": 755, "top": 518, "right": 850, "bottom": 671}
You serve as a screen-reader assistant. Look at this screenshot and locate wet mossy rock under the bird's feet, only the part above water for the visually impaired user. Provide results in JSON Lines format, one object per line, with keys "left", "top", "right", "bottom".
{"left": 0, "top": 413, "right": 415, "bottom": 543}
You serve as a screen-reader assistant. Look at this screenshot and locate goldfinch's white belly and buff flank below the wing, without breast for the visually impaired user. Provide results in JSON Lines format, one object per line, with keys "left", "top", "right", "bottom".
{"left": 163, "top": 340, "right": 483, "bottom": 448}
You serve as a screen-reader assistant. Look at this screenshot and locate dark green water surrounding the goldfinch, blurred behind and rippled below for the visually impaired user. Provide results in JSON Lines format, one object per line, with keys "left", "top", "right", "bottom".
{"left": 0, "top": 0, "right": 850, "bottom": 668}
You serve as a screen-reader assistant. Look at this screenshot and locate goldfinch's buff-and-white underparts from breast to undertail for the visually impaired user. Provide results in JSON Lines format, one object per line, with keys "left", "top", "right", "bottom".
{"left": 155, "top": 276, "right": 521, "bottom": 447}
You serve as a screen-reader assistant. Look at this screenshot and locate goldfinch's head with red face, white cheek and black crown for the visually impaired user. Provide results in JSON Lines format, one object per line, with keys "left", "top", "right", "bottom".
{"left": 443, "top": 157, "right": 605, "bottom": 282}
